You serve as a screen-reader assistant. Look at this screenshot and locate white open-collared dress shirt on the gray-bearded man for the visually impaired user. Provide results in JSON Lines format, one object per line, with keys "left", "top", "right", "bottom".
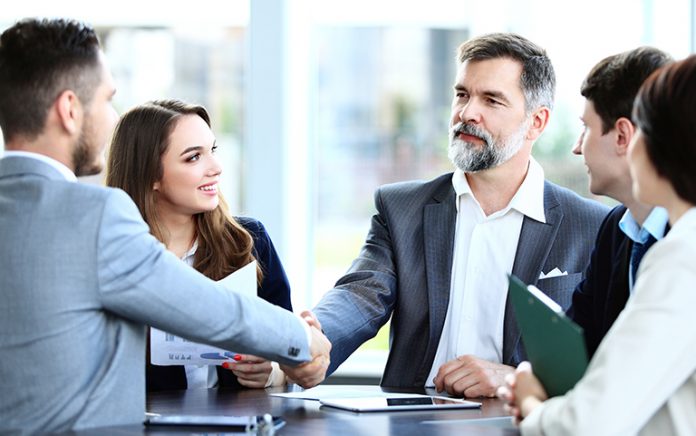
{"left": 426, "top": 159, "right": 546, "bottom": 386}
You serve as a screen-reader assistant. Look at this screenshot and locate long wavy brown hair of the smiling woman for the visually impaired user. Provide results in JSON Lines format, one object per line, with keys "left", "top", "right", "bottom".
{"left": 106, "top": 100, "right": 263, "bottom": 283}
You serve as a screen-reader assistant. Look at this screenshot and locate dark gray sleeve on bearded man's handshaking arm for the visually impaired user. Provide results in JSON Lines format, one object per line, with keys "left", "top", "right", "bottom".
{"left": 314, "top": 189, "right": 397, "bottom": 373}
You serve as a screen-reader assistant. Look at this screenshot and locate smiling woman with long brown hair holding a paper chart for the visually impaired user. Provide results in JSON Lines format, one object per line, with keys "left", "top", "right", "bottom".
{"left": 106, "top": 100, "right": 292, "bottom": 391}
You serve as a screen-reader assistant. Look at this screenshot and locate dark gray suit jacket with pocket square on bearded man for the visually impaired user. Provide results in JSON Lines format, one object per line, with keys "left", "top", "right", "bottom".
{"left": 314, "top": 174, "right": 608, "bottom": 387}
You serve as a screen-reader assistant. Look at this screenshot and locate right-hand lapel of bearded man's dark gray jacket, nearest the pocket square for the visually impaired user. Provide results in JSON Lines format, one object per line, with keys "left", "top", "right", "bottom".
{"left": 503, "top": 182, "right": 563, "bottom": 364}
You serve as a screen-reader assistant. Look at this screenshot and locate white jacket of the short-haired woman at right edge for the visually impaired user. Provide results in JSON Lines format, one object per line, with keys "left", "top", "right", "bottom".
{"left": 521, "top": 208, "right": 696, "bottom": 436}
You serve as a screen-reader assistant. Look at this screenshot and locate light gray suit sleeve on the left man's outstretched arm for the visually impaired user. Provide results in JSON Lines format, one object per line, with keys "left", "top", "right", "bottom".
{"left": 97, "top": 190, "right": 310, "bottom": 365}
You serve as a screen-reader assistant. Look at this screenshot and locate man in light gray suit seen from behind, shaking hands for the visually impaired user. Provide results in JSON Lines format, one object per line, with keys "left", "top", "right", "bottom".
{"left": 0, "top": 20, "right": 330, "bottom": 434}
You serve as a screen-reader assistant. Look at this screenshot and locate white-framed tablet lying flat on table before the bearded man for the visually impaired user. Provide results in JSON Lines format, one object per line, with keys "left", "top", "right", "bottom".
{"left": 319, "top": 394, "right": 481, "bottom": 412}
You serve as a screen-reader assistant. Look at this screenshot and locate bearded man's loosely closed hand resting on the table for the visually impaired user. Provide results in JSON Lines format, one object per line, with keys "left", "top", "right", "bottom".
{"left": 434, "top": 355, "right": 515, "bottom": 397}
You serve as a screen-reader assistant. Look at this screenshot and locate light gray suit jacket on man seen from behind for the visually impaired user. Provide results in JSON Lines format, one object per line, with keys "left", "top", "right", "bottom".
{"left": 0, "top": 157, "right": 310, "bottom": 433}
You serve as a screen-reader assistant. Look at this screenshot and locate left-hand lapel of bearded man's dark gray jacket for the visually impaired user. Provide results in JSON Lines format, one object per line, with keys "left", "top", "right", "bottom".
{"left": 417, "top": 178, "right": 457, "bottom": 382}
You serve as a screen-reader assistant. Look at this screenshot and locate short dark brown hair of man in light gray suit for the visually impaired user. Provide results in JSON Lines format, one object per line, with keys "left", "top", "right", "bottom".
{"left": 0, "top": 19, "right": 101, "bottom": 142}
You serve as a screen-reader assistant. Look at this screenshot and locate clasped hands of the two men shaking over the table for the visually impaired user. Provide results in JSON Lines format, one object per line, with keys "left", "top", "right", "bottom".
{"left": 280, "top": 310, "right": 331, "bottom": 389}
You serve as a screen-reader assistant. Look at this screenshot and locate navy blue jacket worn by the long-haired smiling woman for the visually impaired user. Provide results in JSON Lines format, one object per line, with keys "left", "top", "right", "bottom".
{"left": 146, "top": 217, "right": 292, "bottom": 392}
